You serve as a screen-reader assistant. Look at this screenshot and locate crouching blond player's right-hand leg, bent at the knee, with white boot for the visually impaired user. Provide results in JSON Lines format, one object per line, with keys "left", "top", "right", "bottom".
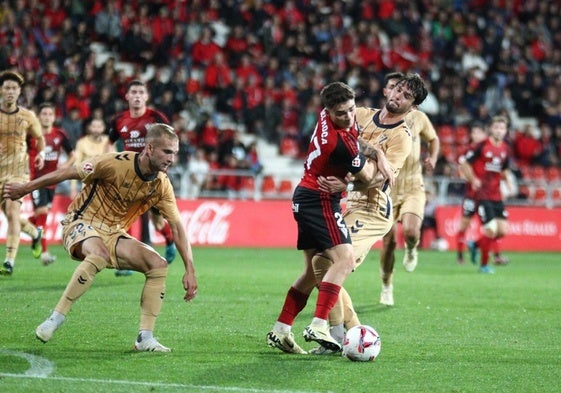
{"left": 115, "top": 237, "right": 171, "bottom": 352}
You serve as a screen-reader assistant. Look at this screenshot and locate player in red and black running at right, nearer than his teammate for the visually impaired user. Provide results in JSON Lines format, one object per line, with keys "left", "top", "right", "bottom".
{"left": 460, "top": 116, "right": 514, "bottom": 273}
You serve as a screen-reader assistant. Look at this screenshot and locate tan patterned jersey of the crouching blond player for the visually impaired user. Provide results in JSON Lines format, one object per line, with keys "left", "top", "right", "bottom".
{"left": 68, "top": 152, "right": 181, "bottom": 233}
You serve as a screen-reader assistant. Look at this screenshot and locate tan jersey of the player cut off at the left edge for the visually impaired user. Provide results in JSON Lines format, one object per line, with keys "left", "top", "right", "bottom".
{"left": 0, "top": 108, "right": 43, "bottom": 182}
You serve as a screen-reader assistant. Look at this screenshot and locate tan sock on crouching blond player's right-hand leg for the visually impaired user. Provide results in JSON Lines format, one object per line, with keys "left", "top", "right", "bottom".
{"left": 140, "top": 267, "right": 168, "bottom": 331}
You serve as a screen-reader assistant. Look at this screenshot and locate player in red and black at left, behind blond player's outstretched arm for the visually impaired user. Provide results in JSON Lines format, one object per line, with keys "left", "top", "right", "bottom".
{"left": 30, "top": 102, "right": 74, "bottom": 265}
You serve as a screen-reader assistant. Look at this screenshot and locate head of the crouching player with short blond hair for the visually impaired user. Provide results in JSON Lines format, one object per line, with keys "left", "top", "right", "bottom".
{"left": 144, "top": 123, "right": 179, "bottom": 172}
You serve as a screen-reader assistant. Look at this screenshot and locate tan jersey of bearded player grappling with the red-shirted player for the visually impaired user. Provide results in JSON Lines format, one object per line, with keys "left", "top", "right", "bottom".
{"left": 347, "top": 108, "right": 413, "bottom": 208}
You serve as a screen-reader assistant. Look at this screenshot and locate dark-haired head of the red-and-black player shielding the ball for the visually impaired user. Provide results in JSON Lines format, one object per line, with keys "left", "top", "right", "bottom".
{"left": 320, "top": 82, "right": 356, "bottom": 129}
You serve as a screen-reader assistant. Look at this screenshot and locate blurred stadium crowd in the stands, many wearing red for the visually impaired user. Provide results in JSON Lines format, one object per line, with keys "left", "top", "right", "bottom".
{"left": 0, "top": 0, "right": 561, "bottom": 196}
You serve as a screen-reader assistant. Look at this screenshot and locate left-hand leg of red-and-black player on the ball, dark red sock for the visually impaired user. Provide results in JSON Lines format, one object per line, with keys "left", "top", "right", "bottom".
{"left": 267, "top": 249, "right": 316, "bottom": 354}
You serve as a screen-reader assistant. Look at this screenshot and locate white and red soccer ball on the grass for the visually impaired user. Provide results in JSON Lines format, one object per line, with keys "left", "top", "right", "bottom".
{"left": 343, "top": 325, "right": 382, "bottom": 362}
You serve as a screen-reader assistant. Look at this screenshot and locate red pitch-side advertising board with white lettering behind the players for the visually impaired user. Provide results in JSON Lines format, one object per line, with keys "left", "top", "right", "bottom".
{"left": 4, "top": 195, "right": 561, "bottom": 251}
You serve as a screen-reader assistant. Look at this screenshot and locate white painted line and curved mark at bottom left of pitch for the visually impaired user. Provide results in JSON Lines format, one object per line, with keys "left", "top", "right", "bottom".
{"left": 0, "top": 349, "right": 322, "bottom": 393}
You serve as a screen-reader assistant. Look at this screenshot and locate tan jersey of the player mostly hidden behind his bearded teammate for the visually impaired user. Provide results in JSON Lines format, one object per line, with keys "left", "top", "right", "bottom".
{"left": 391, "top": 110, "right": 436, "bottom": 198}
